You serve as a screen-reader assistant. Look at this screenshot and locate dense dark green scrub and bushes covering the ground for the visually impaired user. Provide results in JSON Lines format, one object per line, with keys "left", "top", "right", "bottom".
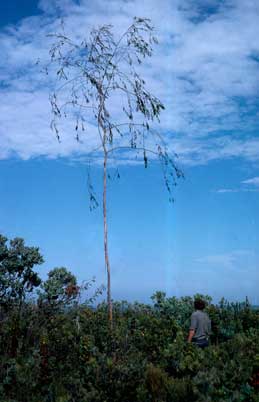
{"left": 0, "top": 237, "right": 259, "bottom": 402}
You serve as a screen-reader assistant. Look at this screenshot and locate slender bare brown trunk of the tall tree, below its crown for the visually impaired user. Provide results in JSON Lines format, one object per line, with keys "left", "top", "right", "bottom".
{"left": 103, "top": 152, "right": 113, "bottom": 328}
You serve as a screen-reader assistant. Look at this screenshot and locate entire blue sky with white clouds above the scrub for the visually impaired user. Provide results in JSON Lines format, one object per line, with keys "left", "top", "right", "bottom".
{"left": 0, "top": 0, "right": 259, "bottom": 304}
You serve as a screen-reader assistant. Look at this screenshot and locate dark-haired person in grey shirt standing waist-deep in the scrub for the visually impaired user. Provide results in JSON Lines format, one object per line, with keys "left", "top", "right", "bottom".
{"left": 188, "top": 299, "right": 211, "bottom": 349}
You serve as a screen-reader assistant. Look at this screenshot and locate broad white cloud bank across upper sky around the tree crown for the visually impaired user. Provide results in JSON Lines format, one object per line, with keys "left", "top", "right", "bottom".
{"left": 0, "top": 0, "right": 259, "bottom": 165}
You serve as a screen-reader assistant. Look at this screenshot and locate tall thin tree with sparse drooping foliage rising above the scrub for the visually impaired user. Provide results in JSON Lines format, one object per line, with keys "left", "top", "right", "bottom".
{"left": 46, "top": 17, "right": 182, "bottom": 325}
